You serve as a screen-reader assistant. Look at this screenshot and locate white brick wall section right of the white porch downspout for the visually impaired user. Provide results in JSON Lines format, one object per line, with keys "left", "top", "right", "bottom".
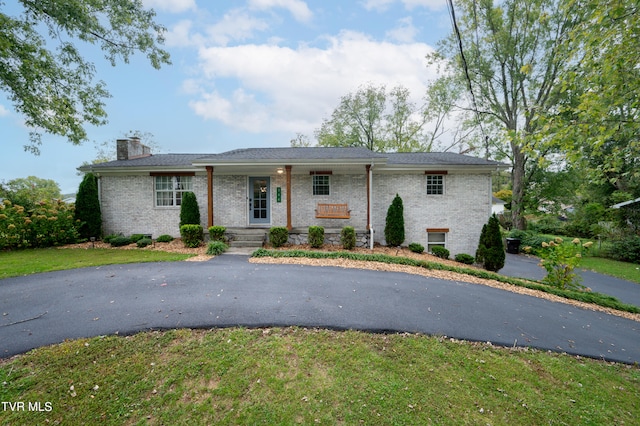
{"left": 373, "top": 173, "right": 491, "bottom": 255}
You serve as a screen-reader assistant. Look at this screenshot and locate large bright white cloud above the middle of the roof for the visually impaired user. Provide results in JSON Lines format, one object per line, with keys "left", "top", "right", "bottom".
{"left": 185, "top": 32, "right": 435, "bottom": 134}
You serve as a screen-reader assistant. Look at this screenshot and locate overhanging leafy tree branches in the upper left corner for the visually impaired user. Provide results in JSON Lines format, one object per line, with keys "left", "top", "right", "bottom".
{"left": 0, "top": 0, "right": 170, "bottom": 154}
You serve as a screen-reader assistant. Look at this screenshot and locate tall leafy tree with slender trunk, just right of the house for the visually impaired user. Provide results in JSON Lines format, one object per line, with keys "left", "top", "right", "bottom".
{"left": 439, "top": 0, "right": 575, "bottom": 229}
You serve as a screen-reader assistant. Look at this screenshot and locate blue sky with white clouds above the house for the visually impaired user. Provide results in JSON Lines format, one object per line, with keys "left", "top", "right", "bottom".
{"left": 0, "top": 0, "right": 451, "bottom": 194}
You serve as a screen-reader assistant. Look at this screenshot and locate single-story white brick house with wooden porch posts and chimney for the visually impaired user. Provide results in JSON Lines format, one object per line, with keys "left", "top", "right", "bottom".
{"left": 80, "top": 139, "right": 506, "bottom": 254}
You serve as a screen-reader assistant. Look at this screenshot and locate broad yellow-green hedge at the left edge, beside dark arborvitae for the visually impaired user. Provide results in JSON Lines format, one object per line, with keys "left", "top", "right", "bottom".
{"left": 0, "top": 200, "right": 79, "bottom": 250}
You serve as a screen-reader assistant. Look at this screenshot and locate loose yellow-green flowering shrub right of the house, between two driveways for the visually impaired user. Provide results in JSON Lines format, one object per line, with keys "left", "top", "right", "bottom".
{"left": 538, "top": 237, "right": 592, "bottom": 290}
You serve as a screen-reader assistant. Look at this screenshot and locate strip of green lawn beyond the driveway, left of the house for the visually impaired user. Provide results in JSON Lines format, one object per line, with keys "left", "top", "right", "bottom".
{"left": 0, "top": 248, "right": 192, "bottom": 279}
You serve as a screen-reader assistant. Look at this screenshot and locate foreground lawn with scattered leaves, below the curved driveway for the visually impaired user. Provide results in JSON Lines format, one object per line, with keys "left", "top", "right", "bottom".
{"left": 0, "top": 328, "right": 640, "bottom": 425}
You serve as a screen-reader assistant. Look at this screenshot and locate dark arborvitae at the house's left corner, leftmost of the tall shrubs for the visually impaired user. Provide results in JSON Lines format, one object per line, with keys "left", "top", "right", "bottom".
{"left": 75, "top": 173, "right": 102, "bottom": 238}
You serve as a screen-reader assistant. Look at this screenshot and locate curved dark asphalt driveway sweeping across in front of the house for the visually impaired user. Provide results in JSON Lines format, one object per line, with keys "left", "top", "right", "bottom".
{"left": 0, "top": 255, "right": 640, "bottom": 363}
